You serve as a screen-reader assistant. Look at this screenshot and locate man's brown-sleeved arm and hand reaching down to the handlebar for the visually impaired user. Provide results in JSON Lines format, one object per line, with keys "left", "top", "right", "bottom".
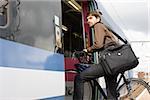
{"left": 87, "top": 23, "right": 105, "bottom": 52}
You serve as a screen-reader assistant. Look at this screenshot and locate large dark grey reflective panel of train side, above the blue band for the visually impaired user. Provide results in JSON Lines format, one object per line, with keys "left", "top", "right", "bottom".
{"left": 0, "top": 0, "right": 61, "bottom": 52}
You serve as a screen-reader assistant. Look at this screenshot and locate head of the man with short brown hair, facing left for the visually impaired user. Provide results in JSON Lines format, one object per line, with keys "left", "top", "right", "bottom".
{"left": 87, "top": 11, "right": 102, "bottom": 27}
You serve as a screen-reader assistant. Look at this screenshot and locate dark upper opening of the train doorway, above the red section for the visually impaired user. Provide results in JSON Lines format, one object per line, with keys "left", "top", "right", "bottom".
{"left": 62, "top": 1, "right": 84, "bottom": 57}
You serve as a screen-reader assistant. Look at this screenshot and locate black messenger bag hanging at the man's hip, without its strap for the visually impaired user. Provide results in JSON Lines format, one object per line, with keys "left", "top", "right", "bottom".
{"left": 99, "top": 44, "right": 139, "bottom": 75}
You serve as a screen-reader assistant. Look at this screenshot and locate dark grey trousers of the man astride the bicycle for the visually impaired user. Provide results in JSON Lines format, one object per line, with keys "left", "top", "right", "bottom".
{"left": 73, "top": 64, "right": 118, "bottom": 100}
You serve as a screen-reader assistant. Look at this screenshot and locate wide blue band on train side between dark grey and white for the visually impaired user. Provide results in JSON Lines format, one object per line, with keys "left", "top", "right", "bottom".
{"left": 0, "top": 39, "right": 64, "bottom": 71}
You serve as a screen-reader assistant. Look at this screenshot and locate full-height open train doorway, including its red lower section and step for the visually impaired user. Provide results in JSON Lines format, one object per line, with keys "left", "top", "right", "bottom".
{"left": 62, "top": 0, "right": 84, "bottom": 100}
